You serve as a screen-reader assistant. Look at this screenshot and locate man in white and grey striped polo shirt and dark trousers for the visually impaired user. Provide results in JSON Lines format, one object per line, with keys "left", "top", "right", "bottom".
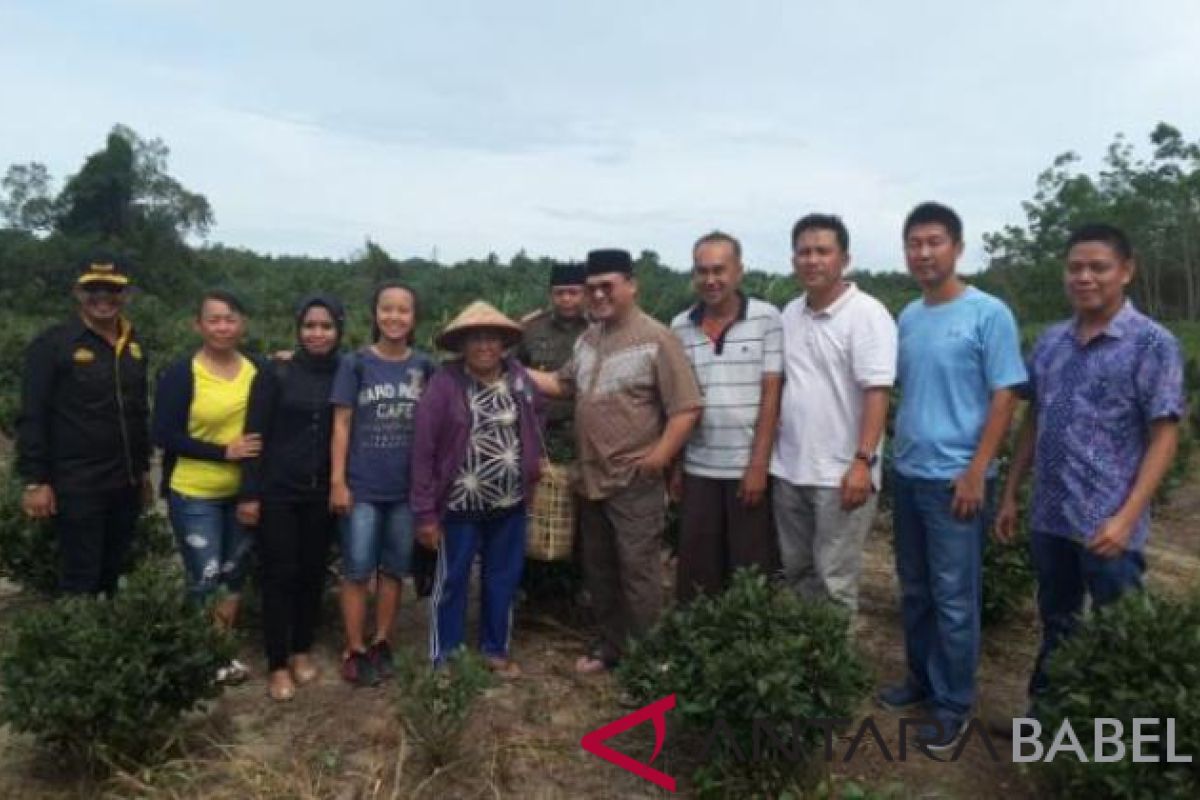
{"left": 671, "top": 231, "right": 782, "bottom": 602}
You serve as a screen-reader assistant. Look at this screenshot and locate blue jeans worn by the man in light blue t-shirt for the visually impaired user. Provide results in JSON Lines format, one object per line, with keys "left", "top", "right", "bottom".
{"left": 893, "top": 473, "right": 995, "bottom": 717}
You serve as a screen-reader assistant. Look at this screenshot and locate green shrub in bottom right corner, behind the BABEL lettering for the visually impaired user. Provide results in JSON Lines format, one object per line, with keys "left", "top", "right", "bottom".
{"left": 1034, "top": 591, "right": 1200, "bottom": 799}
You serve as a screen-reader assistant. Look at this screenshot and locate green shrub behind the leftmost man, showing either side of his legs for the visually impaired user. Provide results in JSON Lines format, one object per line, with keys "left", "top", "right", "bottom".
{"left": 0, "top": 476, "right": 175, "bottom": 595}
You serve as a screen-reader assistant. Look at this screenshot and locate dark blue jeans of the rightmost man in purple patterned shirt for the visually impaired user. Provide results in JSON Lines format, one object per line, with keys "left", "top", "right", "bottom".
{"left": 1030, "top": 531, "right": 1146, "bottom": 696}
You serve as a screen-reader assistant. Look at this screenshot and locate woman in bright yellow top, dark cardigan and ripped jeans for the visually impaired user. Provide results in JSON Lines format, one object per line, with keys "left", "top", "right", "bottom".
{"left": 154, "top": 290, "right": 262, "bottom": 682}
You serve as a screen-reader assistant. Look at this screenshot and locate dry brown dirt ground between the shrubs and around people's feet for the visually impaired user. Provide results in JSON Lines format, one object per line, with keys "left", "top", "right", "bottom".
{"left": 0, "top": 476, "right": 1200, "bottom": 800}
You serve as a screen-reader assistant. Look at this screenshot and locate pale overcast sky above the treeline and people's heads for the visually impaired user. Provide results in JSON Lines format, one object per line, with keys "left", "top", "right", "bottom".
{"left": 0, "top": 0, "right": 1200, "bottom": 270}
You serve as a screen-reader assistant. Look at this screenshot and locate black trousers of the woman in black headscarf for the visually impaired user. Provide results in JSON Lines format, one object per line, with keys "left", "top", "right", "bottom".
{"left": 258, "top": 498, "right": 334, "bottom": 670}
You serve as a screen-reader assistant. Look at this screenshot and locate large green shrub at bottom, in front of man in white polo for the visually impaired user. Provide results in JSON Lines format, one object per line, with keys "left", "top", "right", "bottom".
{"left": 617, "top": 570, "right": 870, "bottom": 796}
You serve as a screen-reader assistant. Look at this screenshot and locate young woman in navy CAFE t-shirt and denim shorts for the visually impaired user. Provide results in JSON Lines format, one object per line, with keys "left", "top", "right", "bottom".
{"left": 330, "top": 283, "right": 434, "bottom": 686}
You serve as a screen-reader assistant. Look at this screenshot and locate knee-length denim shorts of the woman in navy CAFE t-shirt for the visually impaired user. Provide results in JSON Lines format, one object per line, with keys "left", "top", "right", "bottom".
{"left": 342, "top": 500, "right": 413, "bottom": 583}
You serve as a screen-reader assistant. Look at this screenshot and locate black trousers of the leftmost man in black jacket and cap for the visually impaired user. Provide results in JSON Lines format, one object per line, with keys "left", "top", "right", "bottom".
{"left": 54, "top": 486, "right": 142, "bottom": 595}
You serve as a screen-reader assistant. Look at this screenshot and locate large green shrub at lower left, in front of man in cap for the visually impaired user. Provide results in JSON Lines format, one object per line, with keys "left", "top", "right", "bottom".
{"left": 0, "top": 567, "right": 233, "bottom": 765}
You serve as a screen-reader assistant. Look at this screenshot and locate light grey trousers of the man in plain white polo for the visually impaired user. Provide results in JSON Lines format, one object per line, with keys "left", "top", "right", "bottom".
{"left": 772, "top": 477, "right": 878, "bottom": 612}
